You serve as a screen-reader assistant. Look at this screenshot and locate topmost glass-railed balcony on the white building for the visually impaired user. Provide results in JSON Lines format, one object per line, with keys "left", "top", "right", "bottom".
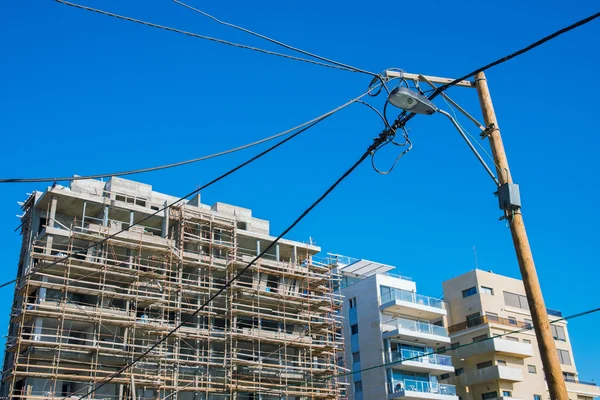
{"left": 379, "top": 288, "right": 446, "bottom": 319}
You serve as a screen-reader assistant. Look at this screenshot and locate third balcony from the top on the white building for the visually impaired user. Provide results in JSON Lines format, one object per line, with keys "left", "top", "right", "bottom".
{"left": 386, "top": 350, "right": 454, "bottom": 375}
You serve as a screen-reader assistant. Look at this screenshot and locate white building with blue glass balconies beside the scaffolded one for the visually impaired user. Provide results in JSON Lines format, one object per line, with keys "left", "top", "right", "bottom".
{"left": 331, "top": 256, "right": 458, "bottom": 400}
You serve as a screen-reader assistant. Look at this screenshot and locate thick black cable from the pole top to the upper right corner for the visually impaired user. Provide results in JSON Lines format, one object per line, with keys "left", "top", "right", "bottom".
{"left": 393, "top": 12, "right": 600, "bottom": 127}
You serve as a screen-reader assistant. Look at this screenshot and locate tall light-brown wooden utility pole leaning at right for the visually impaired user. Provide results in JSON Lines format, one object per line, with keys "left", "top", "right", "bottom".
{"left": 475, "top": 72, "right": 569, "bottom": 400}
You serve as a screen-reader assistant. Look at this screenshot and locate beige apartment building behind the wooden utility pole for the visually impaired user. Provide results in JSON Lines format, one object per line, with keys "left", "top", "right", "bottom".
{"left": 443, "top": 270, "right": 600, "bottom": 400}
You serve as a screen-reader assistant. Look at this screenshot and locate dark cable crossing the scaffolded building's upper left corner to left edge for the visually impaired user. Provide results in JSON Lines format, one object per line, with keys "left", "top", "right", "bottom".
{"left": 0, "top": 89, "right": 371, "bottom": 288}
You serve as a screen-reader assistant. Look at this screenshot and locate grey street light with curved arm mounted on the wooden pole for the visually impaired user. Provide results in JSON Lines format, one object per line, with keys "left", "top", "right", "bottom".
{"left": 387, "top": 86, "right": 500, "bottom": 186}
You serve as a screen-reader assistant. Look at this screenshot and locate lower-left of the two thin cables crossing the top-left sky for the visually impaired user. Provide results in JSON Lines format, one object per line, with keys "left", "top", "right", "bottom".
{"left": 54, "top": 0, "right": 364, "bottom": 72}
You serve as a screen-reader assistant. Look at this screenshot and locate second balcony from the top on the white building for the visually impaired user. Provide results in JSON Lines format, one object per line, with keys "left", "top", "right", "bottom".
{"left": 381, "top": 318, "right": 450, "bottom": 347}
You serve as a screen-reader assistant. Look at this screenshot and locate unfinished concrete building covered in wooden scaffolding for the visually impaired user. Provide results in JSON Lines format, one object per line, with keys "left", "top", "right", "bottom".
{"left": 2, "top": 178, "right": 344, "bottom": 400}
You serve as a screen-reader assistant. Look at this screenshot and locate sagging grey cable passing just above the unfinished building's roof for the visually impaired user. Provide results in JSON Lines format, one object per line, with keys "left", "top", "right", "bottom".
{"left": 0, "top": 100, "right": 356, "bottom": 184}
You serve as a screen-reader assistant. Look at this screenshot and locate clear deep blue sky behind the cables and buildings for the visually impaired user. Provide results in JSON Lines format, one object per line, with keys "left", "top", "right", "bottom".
{"left": 0, "top": 0, "right": 600, "bottom": 381}
